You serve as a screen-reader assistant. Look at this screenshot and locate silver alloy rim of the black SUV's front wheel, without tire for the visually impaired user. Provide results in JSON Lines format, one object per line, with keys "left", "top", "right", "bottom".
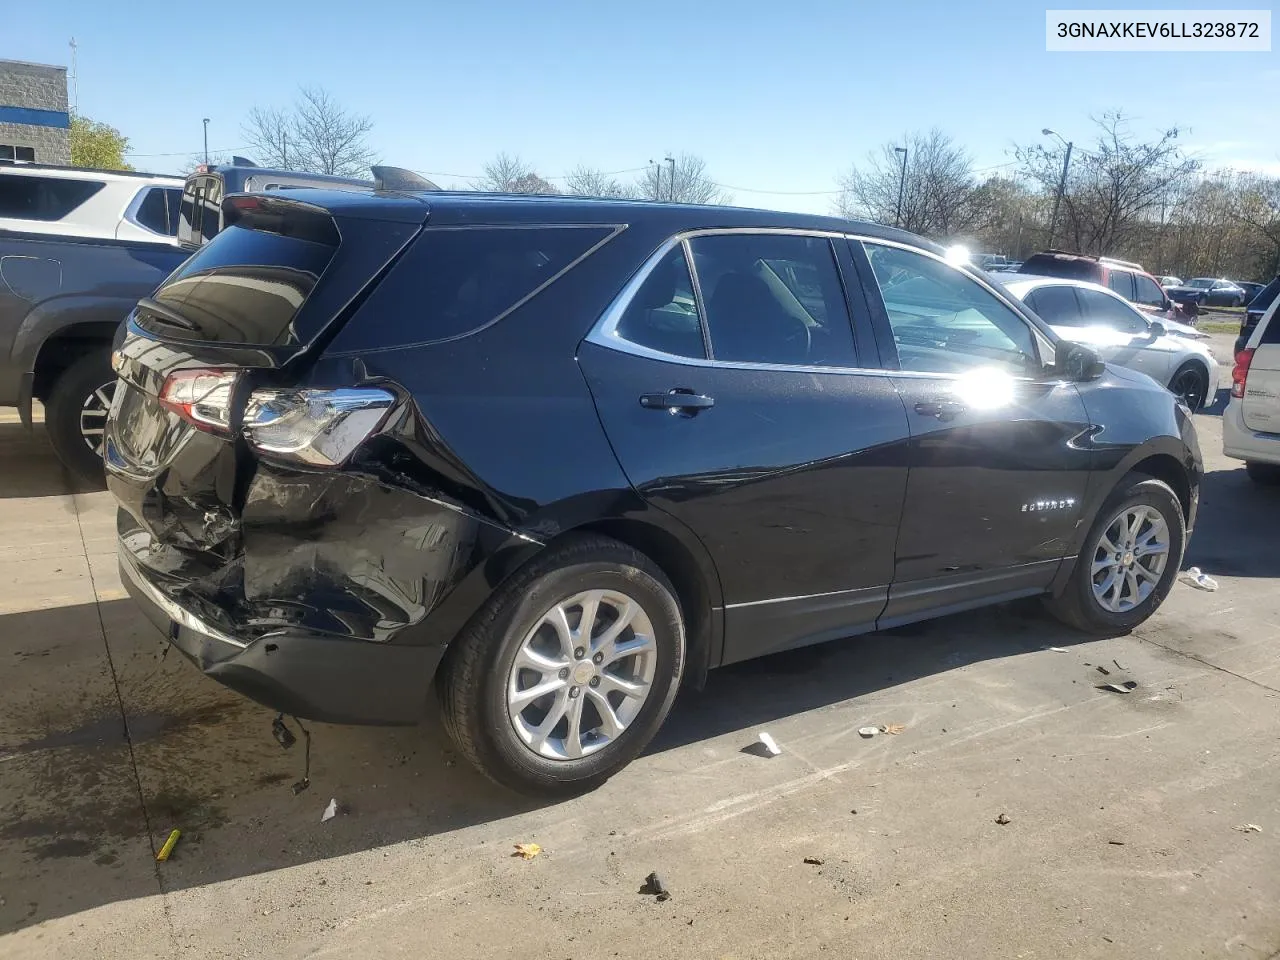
{"left": 1089, "top": 503, "right": 1170, "bottom": 613}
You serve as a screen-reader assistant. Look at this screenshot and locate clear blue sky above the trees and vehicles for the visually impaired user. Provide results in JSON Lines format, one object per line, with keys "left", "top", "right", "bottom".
{"left": 10, "top": 0, "right": 1280, "bottom": 212}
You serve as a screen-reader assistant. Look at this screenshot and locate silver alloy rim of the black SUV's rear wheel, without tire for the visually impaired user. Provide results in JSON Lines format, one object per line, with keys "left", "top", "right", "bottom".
{"left": 507, "top": 590, "right": 658, "bottom": 760}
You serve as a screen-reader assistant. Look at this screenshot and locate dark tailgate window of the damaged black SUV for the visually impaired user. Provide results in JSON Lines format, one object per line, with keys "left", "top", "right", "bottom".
{"left": 137, "top": 227, "right": 337, "bottom": 344}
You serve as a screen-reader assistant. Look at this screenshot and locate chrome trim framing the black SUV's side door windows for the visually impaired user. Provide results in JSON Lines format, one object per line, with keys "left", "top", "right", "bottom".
{"left": 584, "top": 227, "right": 1055, "bottom": 383}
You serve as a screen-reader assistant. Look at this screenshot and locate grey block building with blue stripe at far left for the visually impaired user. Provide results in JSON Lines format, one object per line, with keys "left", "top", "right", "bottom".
{"left": 0, "top": 60, "right": 72, "bottom": 165}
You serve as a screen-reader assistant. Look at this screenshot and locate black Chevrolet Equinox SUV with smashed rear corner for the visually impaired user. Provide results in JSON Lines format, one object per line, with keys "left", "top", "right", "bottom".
{"left": 106, "top": 191, "right": 1201, "bottom": 794}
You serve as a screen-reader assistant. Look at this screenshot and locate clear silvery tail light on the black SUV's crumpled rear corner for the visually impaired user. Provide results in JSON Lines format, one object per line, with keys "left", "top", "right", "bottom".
{"left": 244, "top": 388, "right": 396, "bottom": 467}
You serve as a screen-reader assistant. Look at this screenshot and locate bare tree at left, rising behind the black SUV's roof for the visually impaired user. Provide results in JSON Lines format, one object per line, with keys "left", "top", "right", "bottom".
{"left": 243, "top": 87, "right": 378, "bottom": 177}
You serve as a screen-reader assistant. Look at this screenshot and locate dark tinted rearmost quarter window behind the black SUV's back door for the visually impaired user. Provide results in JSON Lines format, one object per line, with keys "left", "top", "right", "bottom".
{"left": 348, "top": 227, "right": 613, "bottom": 344}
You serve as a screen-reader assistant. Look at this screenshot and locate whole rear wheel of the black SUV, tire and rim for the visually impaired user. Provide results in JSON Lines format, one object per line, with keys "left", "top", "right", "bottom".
{"left": 436, "top": 535, "right": 685, "bottom": 796}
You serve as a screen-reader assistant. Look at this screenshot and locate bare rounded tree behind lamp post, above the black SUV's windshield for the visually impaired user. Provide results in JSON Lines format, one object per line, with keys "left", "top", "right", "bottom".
{"left": 837, "top": 128, "right": 983, "bottom": 238}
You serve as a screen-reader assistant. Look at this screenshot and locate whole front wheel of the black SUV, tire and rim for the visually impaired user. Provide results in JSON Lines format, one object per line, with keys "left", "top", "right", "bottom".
{"left": 1046, "top": 474, "right": 1187, "bottom": 636}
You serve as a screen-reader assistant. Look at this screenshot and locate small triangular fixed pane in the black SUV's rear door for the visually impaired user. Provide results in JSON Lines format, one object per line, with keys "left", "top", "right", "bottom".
{"left": 617, "top": 243, "right": 707, "bottom": 358}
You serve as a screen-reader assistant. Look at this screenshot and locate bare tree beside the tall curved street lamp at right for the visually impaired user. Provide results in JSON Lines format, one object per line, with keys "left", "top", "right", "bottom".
{"left": 1015, "top": 111, "right": 1199, "bottom": 253}
